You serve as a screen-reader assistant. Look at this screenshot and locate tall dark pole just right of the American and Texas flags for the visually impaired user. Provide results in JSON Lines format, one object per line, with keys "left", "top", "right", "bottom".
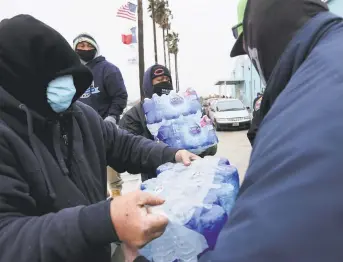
{"left": 137, "top": 0, "right": 145, "bottom": 101}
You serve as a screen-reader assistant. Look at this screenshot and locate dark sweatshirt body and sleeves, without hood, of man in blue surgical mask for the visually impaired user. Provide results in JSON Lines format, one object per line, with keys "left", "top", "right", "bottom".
{"left": 0, "top": 90, "right": 176, "bottom": 262}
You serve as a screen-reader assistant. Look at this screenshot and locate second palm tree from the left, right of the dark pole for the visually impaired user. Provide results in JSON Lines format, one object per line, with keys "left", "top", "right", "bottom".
{"left": 155, "top": 0, "right": 172, "bottom": 67}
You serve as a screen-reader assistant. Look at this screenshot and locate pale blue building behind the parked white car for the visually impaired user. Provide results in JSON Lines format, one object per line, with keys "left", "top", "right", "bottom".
{"left": 226, "top": 0, "right": 343, "bottom": 107}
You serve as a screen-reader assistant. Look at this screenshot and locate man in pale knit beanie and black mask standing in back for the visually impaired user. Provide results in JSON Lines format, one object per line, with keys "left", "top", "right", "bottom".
{"left": 73, "top": 34, "right": 128, "bottom": 196}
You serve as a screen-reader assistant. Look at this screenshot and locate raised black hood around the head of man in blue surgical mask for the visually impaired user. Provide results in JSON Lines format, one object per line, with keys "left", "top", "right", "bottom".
{"left": 0, "top": 15, "right": 93, "bottom": 117}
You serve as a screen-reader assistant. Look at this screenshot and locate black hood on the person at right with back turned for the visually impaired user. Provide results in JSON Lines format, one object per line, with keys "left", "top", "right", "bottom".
{"left": 243, "top": 0, "right": 328, "bottom": 145}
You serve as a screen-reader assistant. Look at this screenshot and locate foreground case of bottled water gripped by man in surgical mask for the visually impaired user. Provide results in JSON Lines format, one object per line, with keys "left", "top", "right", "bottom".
{"left": 140, "top": 157, "right": 239, "bottom": 262}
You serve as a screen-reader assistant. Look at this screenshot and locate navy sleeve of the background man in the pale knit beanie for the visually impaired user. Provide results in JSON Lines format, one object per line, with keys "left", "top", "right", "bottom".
{"left": 104, "top": 64, "right": 128, "bottom": 120}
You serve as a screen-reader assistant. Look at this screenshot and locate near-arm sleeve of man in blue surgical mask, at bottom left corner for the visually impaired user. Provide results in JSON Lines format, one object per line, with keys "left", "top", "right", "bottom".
{"left": 0, "top": 139, "right": 117, "bottom": 262}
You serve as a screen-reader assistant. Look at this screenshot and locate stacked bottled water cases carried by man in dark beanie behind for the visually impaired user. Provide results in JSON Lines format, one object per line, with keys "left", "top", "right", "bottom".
{"left": 143, "top": 89, "right": 218, "bottom": 154}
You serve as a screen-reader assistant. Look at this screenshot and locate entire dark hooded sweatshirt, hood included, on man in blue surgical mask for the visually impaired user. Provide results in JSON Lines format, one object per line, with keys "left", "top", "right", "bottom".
{"left": 0, "top": 15, "right": 176, "bottom": 262}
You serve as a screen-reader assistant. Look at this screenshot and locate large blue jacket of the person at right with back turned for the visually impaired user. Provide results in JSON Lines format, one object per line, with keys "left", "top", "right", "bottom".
{"left": 200, "top": 12, "right": 343, "bottom": 262}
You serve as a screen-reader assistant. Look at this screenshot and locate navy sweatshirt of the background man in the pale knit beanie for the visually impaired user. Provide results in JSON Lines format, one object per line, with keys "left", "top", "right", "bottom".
{"left": 80, "top": 56, "right": 127, "bottom": 120}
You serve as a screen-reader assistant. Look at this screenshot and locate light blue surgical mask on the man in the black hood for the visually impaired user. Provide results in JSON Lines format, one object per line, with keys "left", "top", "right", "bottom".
{"left": 46, "top": 75, "right": 76, "bottom": 113}
